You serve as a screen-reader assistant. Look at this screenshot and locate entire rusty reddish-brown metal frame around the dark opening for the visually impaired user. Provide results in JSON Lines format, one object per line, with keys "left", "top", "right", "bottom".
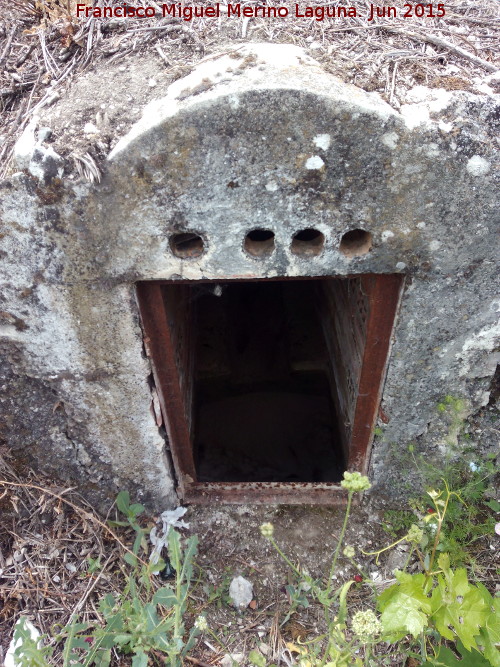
{"left": 137, "top": 274, "right": 404, "bottom": 505}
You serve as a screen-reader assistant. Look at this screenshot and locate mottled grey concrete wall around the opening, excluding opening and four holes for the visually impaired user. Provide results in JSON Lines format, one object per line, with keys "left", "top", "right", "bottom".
{"left": 0, "top": 45, "right": 500, "bottom": 506}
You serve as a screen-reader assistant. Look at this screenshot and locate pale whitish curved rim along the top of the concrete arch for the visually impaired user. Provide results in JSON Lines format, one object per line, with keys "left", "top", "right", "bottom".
{"left": 108, "top": 43, "right": 397, "bottom": 162}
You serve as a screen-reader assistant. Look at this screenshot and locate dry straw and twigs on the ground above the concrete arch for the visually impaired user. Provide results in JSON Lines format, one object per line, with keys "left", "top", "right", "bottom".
{"left": 0, "top": 0, "right": 500, "bottom": 177}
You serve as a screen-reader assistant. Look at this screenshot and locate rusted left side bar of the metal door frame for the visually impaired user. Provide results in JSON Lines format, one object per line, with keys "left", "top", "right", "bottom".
{"left": 137, "top": 282, "right": 196, "bottom": 494}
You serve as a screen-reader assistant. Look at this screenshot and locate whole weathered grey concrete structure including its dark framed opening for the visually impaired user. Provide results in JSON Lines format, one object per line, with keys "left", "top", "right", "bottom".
{"left": 0, "top": 44, "right": 500, "bottom": 507}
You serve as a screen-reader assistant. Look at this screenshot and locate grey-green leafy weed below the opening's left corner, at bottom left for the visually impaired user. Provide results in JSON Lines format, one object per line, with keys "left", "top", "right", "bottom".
{"left": 9, "top": 492, "right": 203, "bottom": 667}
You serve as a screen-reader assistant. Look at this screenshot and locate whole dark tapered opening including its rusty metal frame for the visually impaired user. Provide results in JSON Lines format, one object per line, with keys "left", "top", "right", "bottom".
{"left": 138, "top": 275, "right": 402, "bottom": 504}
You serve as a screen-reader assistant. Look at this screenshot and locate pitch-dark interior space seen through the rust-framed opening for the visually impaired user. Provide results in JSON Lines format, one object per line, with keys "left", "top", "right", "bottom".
{"left": 190, "top": 280, "right": 345, "bottom": 482}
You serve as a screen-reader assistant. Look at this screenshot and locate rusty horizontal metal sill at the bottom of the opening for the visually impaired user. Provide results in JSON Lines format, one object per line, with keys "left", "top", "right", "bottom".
{"left": 183, "top": 482, "right": 347, "bottom": 507}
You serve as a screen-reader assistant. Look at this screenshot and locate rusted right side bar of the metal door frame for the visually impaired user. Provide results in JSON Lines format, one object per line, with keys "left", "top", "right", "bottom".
{"left": 348, "top": 273, "right": 404, "bottom": 474}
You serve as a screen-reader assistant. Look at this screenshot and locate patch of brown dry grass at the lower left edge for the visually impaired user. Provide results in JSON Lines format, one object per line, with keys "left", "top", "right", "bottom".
{"left": 0, "top": 457, "right": 135, "bottom": 664}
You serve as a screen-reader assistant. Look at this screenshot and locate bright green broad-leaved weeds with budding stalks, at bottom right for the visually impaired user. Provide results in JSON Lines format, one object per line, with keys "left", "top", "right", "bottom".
{"left": 260, "top": 471, "right": 500, "bottom": 667}
